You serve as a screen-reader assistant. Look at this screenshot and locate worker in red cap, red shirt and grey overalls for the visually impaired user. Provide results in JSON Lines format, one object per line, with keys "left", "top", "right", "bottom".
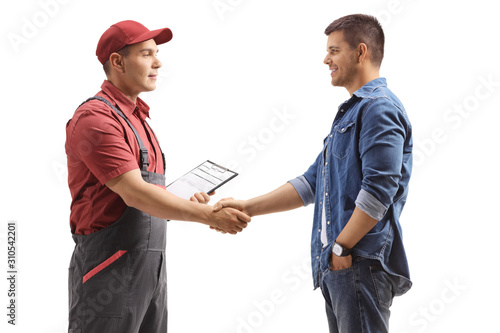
{"left": 66, "top": 21, "right": 250, "bottom": 333}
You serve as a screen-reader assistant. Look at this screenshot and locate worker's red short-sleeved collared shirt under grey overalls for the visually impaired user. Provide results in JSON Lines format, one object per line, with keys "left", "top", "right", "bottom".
{"left": 66, "top": 81, "right": 164, "bottom": 235}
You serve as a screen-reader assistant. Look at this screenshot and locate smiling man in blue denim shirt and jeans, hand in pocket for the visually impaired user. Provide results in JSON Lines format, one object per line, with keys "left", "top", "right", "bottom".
{"left": 214, "top": 15, "right": 412, "bottom": 333}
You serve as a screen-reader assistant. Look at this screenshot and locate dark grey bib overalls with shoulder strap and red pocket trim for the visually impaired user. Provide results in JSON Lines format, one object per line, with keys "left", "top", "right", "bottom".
{"left": 68, "top": 96, "right": 168, "bottom": 333}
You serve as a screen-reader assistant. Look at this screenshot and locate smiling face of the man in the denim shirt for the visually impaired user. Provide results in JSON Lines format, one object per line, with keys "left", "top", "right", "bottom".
{"left": 323, "top": 31, "right": 359, "bottom": 94}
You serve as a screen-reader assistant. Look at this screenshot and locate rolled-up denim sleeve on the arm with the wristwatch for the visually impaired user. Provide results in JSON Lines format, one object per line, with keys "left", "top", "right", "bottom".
{"left": 356, "top": 98, "right": 410, "bottom": 220}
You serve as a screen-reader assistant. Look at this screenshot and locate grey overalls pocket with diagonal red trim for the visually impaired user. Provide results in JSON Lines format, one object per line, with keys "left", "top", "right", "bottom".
{"left": 78, "top": 251, "right": 130, "bottom": 318}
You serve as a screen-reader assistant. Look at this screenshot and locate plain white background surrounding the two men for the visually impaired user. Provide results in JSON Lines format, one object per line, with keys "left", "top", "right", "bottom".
{"left": 0, "top": 0, "right": 500, "bottom": 333}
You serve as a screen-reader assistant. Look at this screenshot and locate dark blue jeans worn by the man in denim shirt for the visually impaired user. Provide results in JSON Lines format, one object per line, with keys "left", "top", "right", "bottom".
{"left": 321, "top": 257, "right": 395, "bottom": 333}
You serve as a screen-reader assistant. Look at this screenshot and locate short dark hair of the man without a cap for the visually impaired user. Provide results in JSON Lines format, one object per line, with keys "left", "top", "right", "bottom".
{"left": 325, "top": 14, "right": 385, "bottom": 67}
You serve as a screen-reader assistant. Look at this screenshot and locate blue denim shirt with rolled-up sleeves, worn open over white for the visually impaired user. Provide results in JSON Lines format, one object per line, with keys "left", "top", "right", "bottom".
{"left": 290, "top": 78, "right": 412, "bottom": 295}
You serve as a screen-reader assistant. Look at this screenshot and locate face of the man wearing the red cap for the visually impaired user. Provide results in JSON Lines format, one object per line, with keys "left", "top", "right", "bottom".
{"left": 112, "top": 39, "right": 161, "bottom": 102}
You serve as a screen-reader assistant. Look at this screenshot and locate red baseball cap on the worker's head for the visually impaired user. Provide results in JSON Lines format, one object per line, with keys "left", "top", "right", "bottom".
{"left": 95, "top": 20, "right": 172, "bottom": 65}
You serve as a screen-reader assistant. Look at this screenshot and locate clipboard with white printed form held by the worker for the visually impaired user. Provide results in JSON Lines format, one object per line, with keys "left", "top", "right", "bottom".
{"left": 166, "top": 160, "right": 238, "bottom": 200}
